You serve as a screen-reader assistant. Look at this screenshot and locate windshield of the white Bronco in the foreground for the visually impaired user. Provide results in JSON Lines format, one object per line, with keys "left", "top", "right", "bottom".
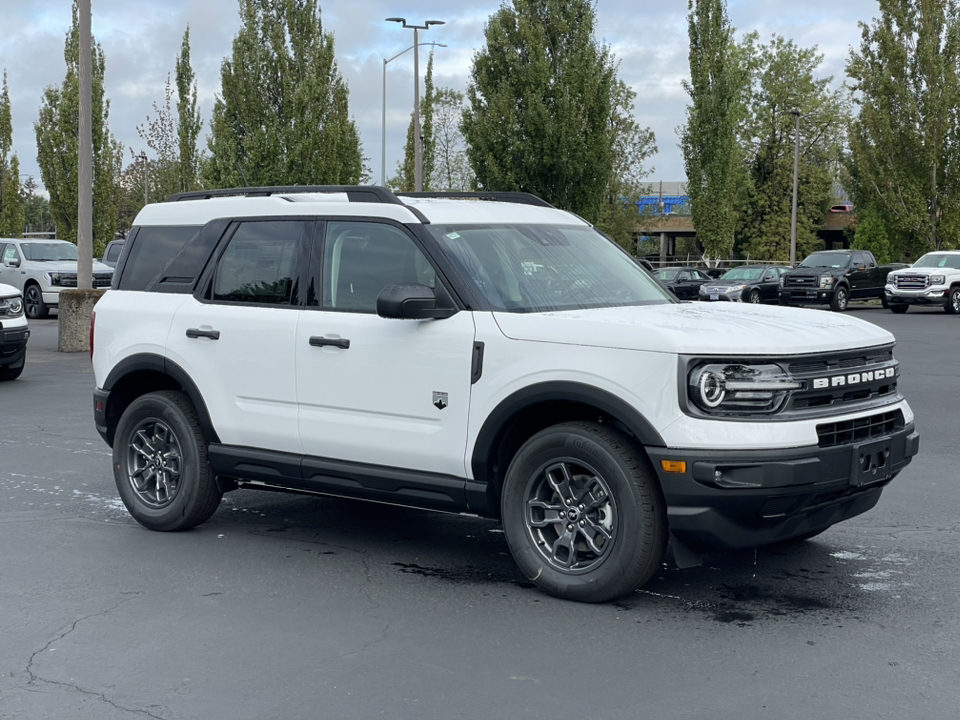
{"left": 427, "top": 224, "right": 676, "bottom": 313}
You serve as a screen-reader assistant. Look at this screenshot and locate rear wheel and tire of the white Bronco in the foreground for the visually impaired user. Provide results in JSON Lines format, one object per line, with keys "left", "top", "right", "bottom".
{"left": 113, "top": 390, "right": 223, "bottom": 532}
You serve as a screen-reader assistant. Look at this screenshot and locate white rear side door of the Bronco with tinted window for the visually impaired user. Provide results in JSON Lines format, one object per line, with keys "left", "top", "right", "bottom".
{"left": 167, "top": 219, "right": 314, "bottom": 453}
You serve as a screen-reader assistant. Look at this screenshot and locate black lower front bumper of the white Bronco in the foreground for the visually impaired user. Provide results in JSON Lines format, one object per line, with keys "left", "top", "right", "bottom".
{"left": 647, "top": 423, "right": 920, "bottom": 552}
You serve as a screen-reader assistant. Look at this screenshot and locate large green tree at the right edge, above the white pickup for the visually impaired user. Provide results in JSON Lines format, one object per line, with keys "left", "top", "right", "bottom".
{"left": 847, "top": 0, "right": 960, "bottom": 255}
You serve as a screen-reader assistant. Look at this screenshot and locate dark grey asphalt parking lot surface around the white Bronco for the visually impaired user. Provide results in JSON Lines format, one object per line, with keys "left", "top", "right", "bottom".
{"left": 0, "top": 304, "right": 960, "bottom": 720}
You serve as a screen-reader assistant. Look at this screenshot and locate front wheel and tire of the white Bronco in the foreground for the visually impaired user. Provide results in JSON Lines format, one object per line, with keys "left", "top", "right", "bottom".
{"left": 501, "top": 422, "right": 667, "bottom": 603}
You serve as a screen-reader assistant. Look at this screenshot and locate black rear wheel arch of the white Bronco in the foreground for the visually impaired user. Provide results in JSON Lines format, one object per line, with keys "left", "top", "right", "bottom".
{"left": 103, "top": 353, "right": 220, "bottom": 446}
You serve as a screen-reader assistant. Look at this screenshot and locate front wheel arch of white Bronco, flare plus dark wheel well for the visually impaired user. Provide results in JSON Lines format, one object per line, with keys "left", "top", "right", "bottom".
{"left": 467, "top": 381, "right": 665, "bottom": 517}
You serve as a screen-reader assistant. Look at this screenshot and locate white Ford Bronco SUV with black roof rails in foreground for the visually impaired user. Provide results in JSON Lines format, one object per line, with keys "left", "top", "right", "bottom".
{"left": 93, "top": 188, "right": 919, "bottom": 602}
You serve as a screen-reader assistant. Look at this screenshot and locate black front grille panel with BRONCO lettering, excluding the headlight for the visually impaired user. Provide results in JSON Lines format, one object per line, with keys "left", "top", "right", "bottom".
{"left": 680, "top": 344, "right": 903, "bottom": 422}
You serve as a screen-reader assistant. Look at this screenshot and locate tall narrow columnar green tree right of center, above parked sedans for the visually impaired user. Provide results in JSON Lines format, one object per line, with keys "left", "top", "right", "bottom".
{"left": 680, "top": 0, "right": 749, "bottom": 258}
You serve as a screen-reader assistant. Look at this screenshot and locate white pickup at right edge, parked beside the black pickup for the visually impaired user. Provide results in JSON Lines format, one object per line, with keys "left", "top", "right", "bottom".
{"left": 883, "top": 250, "right": 960, "bottom": 315}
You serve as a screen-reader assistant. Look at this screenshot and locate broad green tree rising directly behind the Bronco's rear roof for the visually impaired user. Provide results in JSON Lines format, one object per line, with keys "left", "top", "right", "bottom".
{"left": 204, "top": 0, "right": 364, "bottom": 188}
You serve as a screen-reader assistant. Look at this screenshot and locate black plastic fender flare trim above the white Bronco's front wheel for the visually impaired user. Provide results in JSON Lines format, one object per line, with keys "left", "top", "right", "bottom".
{"left": 471, "top": 380, "right": 666, "bottom": 484}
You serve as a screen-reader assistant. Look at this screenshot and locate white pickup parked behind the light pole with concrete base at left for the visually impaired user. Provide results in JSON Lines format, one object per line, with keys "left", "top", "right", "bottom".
{"left": 0, "top": 238, "right": 113, "bottom": 319}
